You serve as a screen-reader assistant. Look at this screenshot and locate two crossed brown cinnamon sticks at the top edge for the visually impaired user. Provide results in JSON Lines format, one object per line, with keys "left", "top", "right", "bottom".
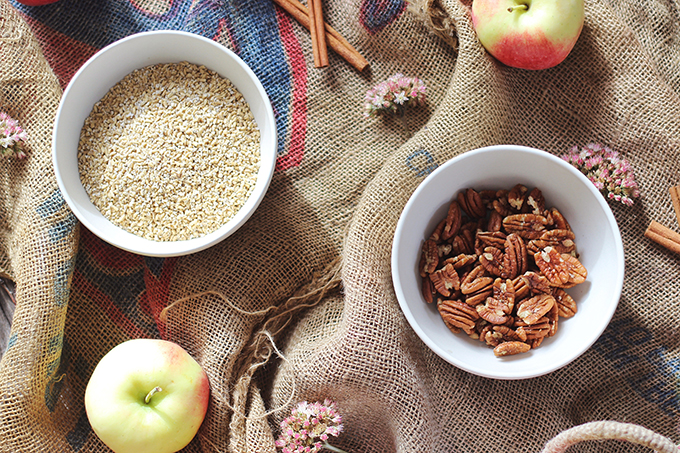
{"left": 274, "top": 0, "right": 368, "bottom": 71}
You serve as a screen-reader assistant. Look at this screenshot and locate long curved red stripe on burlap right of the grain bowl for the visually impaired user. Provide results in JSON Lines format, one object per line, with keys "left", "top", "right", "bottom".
{"left": 276, "top": 8, "right": 307, "bottom": 170}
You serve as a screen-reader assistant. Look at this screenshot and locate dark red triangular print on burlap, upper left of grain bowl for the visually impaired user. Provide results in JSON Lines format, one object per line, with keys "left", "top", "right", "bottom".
{"left": 22, "top": 14, "right": 99, "bottom": 89}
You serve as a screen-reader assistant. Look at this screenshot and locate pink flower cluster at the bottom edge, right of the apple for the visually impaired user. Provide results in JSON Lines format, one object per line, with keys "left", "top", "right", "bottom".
{"left": 276, "top": 399, "right": 342, "bottom": 453}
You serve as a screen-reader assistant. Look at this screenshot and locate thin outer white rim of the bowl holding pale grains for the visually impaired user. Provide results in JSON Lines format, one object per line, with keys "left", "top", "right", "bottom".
{"left": 52, "top": 30, "right": 278, "bottom": 257}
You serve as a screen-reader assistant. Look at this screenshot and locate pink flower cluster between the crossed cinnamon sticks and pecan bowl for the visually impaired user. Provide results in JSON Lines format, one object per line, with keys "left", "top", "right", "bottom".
{"left": 364, "top": 74, "right": 426, "bottom": 117}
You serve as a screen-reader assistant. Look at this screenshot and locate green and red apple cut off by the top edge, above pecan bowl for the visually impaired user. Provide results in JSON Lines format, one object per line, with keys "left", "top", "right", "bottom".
{"left": 472, "top": 0, "right": 585, "bottom": 70}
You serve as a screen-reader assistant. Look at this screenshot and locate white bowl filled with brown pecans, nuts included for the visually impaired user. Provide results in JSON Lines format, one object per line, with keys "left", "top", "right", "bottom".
{"left": 392, "top": 145, "right": 624, "bottom": 379}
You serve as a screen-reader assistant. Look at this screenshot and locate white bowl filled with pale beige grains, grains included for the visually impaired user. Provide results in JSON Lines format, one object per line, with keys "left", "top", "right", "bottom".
{"left": 52, "top": 31, "right": 277, "bottom": 257}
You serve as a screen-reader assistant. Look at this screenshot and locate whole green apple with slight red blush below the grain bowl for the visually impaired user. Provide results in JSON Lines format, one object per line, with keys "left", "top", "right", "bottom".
{"left": 85, "top": 339, "right": 210, "bottom": 453}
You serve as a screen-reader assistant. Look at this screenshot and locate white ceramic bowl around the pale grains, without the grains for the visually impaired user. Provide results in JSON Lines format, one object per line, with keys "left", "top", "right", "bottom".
{"left": 52, "top": 31, "right": 277, "bottom": 257}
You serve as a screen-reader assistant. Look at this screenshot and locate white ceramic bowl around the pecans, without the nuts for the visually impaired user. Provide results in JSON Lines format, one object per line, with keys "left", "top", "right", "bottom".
{"left": 392, "top": 145, "right": 624, "bottom": 379}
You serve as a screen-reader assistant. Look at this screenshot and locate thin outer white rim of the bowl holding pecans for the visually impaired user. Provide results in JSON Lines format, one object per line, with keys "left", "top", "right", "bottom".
{"left": 391, "top": 145, "right": 625, "bottom": 380}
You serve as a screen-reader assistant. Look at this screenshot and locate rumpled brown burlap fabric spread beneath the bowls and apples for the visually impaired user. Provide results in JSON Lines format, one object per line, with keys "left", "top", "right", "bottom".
{"left": 0, "top": 0, "right": 680, "bottom": 452}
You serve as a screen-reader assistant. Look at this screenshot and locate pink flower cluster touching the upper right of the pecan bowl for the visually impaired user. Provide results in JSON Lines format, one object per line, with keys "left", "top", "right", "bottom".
{"left": 562, "top": 143, "right": 640, "bottom": 206}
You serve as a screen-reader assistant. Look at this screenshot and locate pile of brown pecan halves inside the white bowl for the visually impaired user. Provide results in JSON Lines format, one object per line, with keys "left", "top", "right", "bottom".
{"left": 419, "top": 184, "right": 588, "bottom": 357}
